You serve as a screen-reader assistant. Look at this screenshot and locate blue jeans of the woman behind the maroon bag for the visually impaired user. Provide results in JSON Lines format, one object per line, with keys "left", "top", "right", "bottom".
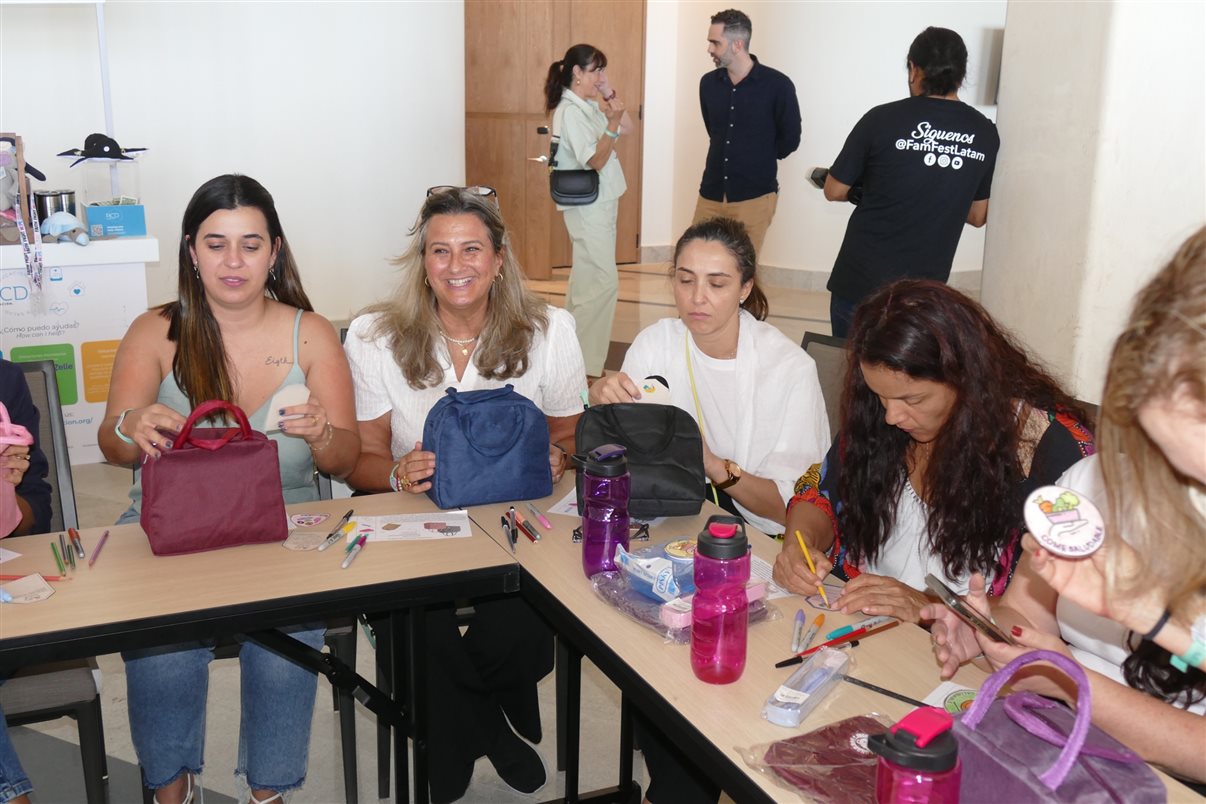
{"left": 117, "top": 506, "right": 326, "bottom": 793}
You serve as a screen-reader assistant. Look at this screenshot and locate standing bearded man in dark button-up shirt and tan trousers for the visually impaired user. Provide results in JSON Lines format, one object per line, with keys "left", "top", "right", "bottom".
{"left": 692, "top": 8, "right": 800, "bottom": 261}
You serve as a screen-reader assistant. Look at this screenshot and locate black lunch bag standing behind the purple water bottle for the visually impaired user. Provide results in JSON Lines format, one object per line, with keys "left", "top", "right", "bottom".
{"left": 575, "top": 403, "right": 708, "bottom": 520}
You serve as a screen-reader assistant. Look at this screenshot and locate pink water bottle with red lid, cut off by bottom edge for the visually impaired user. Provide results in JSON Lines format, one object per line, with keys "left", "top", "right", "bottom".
{"left": 867, "top": 706, "right": 962, "bottom": 804}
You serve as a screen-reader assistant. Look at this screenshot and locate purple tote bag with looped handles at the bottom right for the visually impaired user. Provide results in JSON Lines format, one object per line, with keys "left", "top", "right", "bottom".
{"left": 954, "top": 651, "right": 1167, "bottom": 804}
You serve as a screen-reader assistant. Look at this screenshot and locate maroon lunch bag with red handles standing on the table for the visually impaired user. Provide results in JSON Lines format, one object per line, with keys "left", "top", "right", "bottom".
{"left": 139, "top": 399, "right": 289, "bottom": 556}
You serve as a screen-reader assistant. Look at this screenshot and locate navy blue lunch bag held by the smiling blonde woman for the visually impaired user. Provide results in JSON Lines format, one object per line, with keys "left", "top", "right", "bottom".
{"left": 423, "top": 383, "right": 552, "bottom": 509}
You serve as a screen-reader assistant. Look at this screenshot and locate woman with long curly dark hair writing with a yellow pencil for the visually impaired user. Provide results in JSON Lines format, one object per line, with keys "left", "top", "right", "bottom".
{"left": 774, "top": 280, "right": 1094, "bottom": 622}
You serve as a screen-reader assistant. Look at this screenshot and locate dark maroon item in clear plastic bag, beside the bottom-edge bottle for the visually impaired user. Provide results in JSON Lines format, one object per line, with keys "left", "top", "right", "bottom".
{"left": 740, "top": 715, "right": 892, "bottom": 804}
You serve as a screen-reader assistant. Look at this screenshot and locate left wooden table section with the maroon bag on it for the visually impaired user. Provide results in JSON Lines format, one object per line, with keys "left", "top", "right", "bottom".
{"left": 0, "top": 494, "right": 520, "bottom": 802}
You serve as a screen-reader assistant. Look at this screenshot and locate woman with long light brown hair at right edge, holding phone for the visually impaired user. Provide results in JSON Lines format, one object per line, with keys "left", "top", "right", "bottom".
{"left": 923, "top": 229, "right": 1206, "bottom": 782}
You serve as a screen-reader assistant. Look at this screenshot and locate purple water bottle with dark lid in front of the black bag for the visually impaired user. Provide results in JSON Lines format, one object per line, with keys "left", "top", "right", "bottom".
{"left": 574, "top": 444, "right": 632, "bottom": 577}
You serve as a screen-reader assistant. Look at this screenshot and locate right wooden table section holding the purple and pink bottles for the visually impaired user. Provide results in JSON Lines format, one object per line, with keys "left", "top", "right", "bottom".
{"left": 470, "top": 482, "right": 1193, "bottom": 804}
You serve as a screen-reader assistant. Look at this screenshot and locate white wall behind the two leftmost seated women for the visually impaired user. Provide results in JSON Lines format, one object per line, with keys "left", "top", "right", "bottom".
{"left": 0, "top": 0, "right": 464, "bottom": 318}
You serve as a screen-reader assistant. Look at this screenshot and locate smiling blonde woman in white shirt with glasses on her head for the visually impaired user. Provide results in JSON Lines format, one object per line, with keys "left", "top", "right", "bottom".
{"left": 344, "top": 187, "right": 586, "bottom": 802}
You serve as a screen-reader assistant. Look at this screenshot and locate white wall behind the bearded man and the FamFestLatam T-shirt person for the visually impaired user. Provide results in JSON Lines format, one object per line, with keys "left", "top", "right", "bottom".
{"left": 642, "top": 0, "right": 1006, "bottom": 275}
